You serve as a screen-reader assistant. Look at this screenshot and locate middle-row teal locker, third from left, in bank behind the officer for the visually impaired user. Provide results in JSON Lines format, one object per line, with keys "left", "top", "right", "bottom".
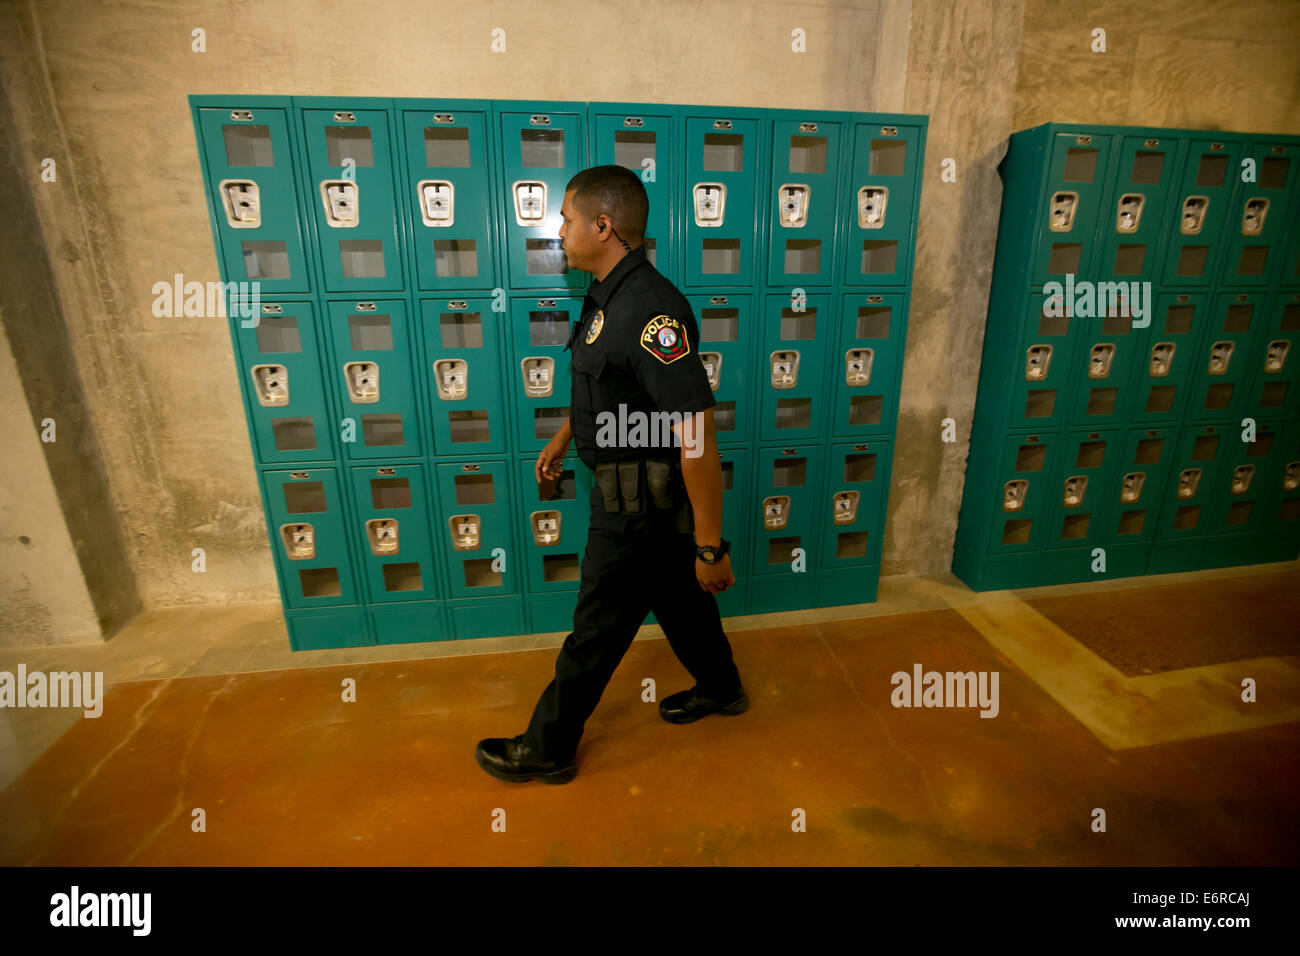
{"left": 420, "top": 297, "right": 510, "bottom": 457}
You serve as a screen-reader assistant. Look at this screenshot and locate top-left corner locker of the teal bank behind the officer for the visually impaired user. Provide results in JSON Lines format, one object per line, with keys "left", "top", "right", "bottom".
{"left": 194, "top": 98, "right": 311, "bottom": 295}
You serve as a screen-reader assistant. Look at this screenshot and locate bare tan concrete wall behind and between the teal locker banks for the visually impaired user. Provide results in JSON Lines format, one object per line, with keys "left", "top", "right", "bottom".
{"left": 0, "top": 0, "right": 1300, "bottom": 647}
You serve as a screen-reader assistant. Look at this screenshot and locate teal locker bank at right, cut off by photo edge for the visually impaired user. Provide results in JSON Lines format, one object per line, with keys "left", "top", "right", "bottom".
{"left": 953, "top": 124, "right": 1300, "bottom": 591}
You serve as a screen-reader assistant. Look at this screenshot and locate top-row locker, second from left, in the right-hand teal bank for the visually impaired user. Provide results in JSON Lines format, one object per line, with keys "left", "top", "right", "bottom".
{"left": 1095, "top": 130, "right": 1183, "bottom": 282}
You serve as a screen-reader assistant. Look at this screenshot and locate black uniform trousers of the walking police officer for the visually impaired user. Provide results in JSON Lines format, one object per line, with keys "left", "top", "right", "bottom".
{"left": 525, "top": 488, "right": 741, "bottom": 765}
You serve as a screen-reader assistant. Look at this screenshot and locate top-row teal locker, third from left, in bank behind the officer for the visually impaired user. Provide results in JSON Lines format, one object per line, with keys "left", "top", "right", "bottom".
{"left": 400, "top": 100, "right": 499, "bottom": 291}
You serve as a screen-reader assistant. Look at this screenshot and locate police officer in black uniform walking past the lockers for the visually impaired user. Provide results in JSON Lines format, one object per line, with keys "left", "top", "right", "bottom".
{"left": 475, "top": 165, "right": 749, "bottom": 783}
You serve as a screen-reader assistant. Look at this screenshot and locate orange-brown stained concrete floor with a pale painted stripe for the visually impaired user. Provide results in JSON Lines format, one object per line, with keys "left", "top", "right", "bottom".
{"left": 0, "top": 562, "right": 1300, "bottom": 866}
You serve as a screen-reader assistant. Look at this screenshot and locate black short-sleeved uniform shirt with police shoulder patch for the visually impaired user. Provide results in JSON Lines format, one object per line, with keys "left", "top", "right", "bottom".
{"left": 566, "top": 246, "right": 716, "bottom": 468}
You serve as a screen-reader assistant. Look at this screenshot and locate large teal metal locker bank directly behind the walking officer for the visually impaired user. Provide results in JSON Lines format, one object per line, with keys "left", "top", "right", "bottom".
{"left": 190, "top": 96, "right": 927, "bottom": 649}
